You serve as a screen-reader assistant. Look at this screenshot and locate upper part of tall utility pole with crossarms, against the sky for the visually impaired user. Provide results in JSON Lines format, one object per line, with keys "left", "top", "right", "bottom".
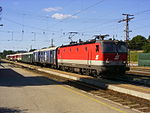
{"left": 118, "top": 14, "right": 134, "bottom": 42}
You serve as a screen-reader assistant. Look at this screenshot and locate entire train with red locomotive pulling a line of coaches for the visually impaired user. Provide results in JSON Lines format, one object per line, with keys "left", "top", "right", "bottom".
{"left": 6, "top": 35, "right": 129, "bottom": 78}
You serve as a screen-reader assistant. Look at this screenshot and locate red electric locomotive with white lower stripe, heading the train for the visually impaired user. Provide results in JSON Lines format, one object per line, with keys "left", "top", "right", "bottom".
{"left": 57, "top": 36, "right": 127, "bottom": 78}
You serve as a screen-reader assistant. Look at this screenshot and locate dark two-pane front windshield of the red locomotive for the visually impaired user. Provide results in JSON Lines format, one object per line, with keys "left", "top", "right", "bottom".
{"left": 103, "top": 42, "right": 127, "bottom": 53}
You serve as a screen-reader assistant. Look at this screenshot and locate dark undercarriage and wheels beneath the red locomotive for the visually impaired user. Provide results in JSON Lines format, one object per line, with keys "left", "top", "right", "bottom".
{"left": 58, "top": 64, "right": 129, "bottom": 79}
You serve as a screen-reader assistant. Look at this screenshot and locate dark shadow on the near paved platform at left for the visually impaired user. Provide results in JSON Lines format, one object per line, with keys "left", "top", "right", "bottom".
{"left": 0, "top": 68, "right": 59, "bottom": 87}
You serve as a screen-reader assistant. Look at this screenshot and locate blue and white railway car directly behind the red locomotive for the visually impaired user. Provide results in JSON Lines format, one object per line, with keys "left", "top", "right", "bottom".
{"left": 33, "top": 47, "right": 57, "bottom": 66}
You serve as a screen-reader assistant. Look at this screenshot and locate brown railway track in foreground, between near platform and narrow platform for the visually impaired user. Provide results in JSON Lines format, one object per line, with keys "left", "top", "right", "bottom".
{"left": 8, "top": 65, "right": 150, "bottom": 113}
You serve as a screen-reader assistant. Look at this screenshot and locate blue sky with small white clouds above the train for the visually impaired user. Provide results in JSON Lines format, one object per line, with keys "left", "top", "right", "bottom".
{"left": 0, "top": 0, "right": 150, "bottom": 51}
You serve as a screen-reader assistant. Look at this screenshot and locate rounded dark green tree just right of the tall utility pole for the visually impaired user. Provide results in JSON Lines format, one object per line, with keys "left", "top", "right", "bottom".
{"left": 129, "top": 35, "right": 147, "bottom": 50}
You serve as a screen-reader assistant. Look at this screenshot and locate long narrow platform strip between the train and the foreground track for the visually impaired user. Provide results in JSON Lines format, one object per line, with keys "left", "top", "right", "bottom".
{"left": 3, "top": 60, "right": 150, "bottom": 100}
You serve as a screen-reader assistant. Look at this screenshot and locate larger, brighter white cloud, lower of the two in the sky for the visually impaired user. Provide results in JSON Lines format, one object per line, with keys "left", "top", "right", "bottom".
{"left": 51, "top": 13, "right": 77, "bottom": 20}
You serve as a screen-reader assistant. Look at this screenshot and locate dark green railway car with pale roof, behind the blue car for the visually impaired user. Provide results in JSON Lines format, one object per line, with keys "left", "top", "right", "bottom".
{"left": 21, "top": 52, "right": 33, "bottom": 64}
